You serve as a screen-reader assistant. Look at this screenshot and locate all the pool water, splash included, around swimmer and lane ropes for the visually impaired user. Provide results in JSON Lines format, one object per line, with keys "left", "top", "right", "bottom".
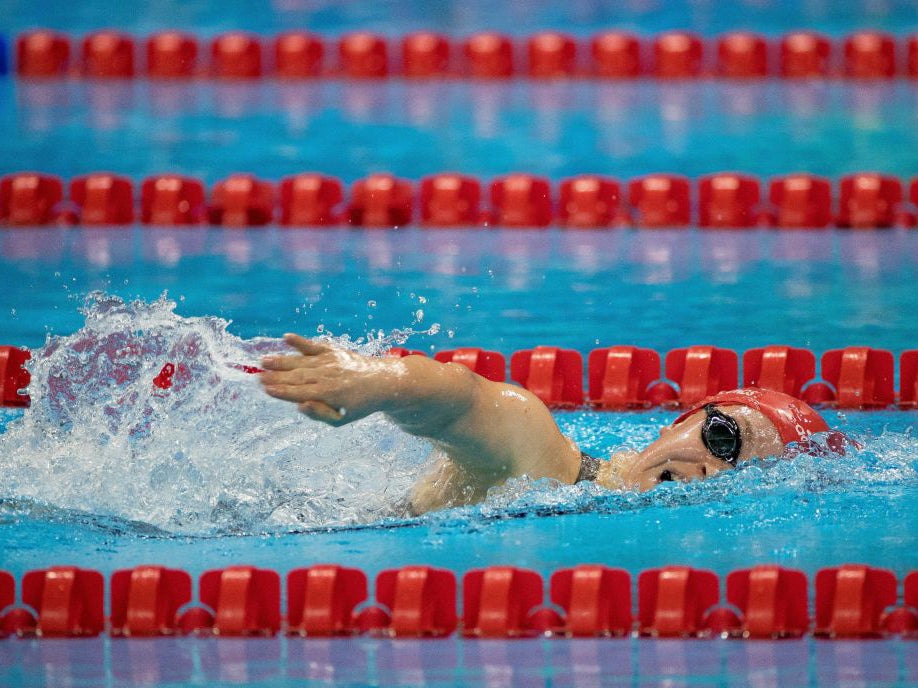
{"left": 0, "top": 0, "right": 918, "bottom": 686}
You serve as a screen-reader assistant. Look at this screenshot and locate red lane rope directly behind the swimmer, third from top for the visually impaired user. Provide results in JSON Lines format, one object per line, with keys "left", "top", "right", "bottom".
{"left": 0, "top": 345, "right": 918, "bottom": 411}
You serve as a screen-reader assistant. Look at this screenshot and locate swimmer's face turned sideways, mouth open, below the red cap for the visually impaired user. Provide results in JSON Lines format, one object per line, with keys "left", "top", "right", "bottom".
{"left": 621, "top": 405, "right": 784, "bottom": 491}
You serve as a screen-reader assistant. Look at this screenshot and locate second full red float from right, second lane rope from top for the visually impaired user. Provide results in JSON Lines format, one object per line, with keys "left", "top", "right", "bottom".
{"left": 768, "top": 174, "right": 832, "bottom": 229}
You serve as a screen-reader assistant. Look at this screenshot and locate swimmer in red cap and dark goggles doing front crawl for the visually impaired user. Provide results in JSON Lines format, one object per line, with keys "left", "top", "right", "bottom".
{"left": 261, "top": 334, "right": 829, "bottom": 513}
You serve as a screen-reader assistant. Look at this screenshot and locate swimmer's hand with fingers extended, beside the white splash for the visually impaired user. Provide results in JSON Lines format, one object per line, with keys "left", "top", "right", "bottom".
{"left": 261, "top": 334, "right": 395, "bottom": 426}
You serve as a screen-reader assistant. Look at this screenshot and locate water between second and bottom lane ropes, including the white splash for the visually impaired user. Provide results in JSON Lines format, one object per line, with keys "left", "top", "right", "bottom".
{"left": 0, "top": 229, "right": 918, "bottom": 574}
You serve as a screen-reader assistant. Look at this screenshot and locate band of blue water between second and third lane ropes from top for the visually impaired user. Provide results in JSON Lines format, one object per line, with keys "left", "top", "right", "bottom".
{"left": 0, "top": 228, "right": 918, "bottom": 355}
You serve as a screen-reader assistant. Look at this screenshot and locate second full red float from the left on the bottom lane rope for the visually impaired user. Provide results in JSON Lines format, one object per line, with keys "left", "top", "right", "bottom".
{"left": 109, "top": 566, "right": 191, "bottom": 638}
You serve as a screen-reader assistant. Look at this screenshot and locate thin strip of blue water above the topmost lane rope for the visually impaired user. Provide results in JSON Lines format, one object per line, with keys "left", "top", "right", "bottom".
{"left": 0, "top": 0, "right": 918, "bottom": 36}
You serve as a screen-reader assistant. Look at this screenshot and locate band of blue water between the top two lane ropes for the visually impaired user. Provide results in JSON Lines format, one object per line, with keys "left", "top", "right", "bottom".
{"left": 0, "top": 78, "right": 918, "bottom": 184}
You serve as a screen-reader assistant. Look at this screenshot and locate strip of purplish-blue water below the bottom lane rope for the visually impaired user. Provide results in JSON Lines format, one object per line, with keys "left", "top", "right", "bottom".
{"left": 0, "top": 637, "right": 918, "bottom": 688}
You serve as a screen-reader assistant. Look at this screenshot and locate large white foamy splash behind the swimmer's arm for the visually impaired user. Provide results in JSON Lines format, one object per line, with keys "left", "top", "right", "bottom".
{"left": 0, "top": 293, "right": 430, "bottom": 535}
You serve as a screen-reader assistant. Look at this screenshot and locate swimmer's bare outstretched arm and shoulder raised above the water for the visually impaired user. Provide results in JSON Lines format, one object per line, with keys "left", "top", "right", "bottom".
{"left": 261, "top": 335, "right": 580, "bottom": 511}
